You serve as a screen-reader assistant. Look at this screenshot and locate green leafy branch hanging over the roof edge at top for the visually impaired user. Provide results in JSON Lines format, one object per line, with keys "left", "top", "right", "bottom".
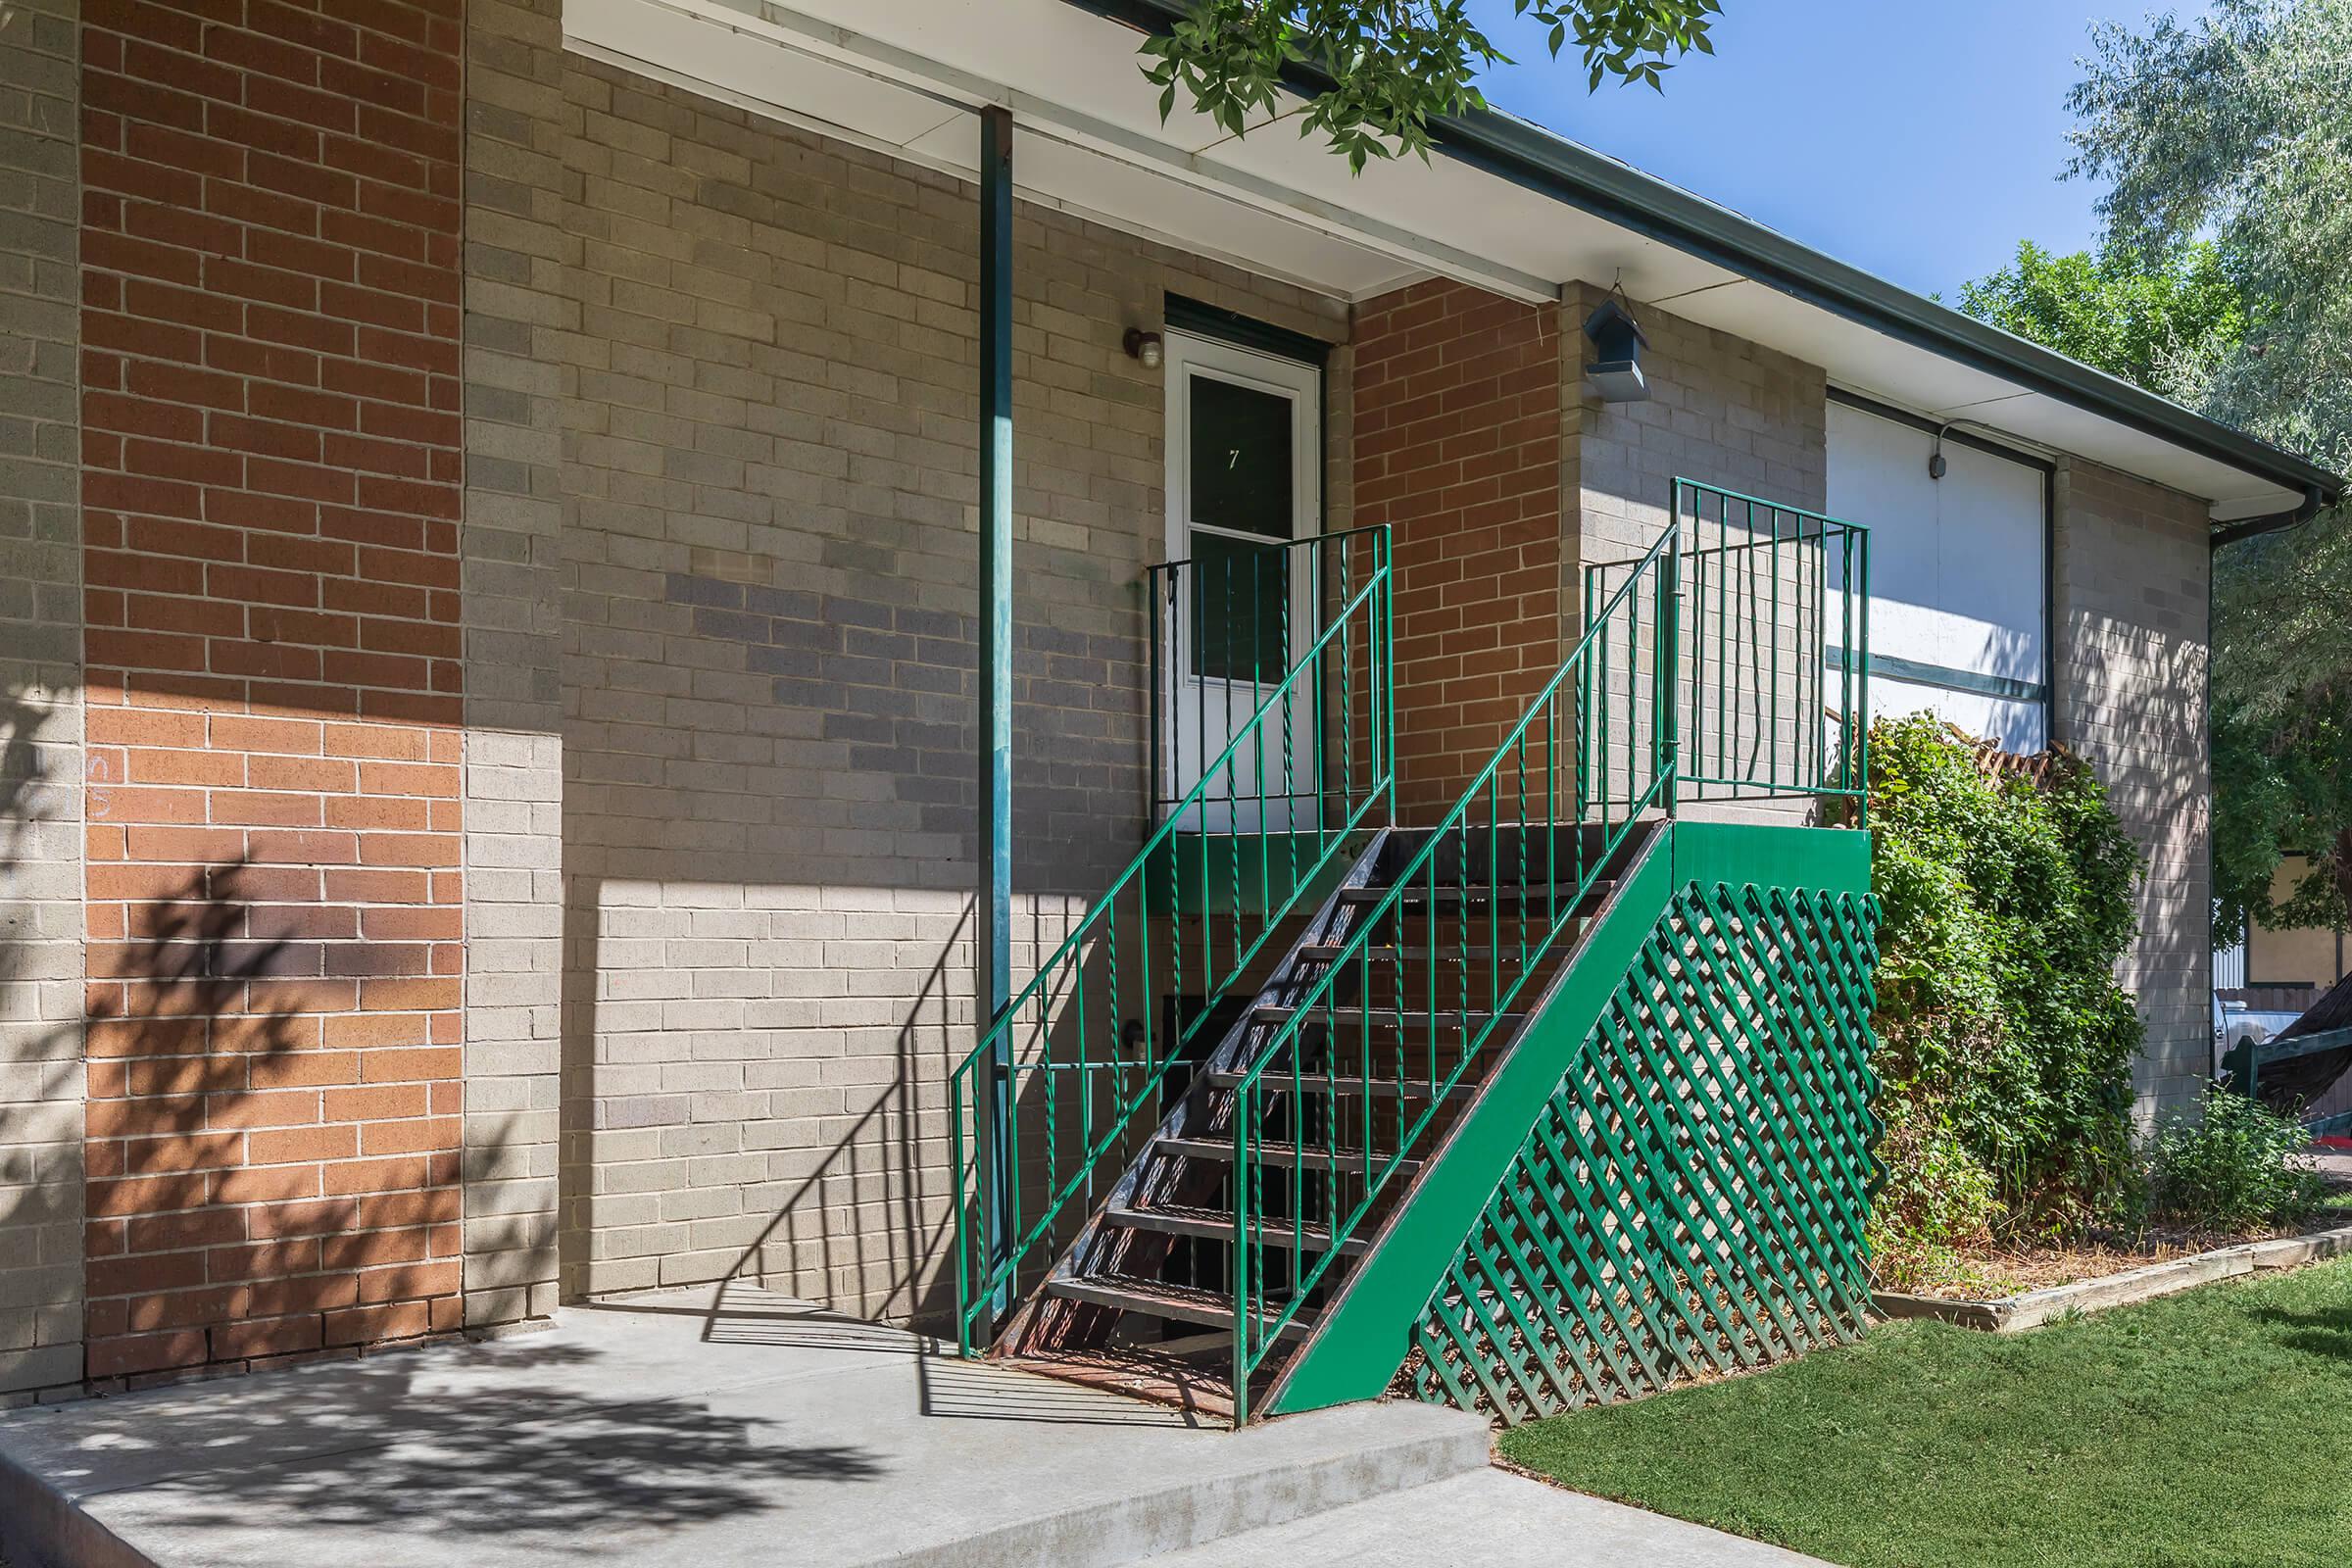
{"left": 1143, "top": 0, "right": 1722, "bottom": 172}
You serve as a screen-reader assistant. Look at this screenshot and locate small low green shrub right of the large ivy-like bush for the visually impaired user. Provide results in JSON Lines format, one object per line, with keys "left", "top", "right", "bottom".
{"left": 2147, "top": 1089, "right": 2328, "bottom": 1230}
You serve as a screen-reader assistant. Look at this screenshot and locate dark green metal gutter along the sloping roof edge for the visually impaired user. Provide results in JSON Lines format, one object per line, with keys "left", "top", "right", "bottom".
{"left": 1068, "top": 0, "right": 2345, "bottom": 510}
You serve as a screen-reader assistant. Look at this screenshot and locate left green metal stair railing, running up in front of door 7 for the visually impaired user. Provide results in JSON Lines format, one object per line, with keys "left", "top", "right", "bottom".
{"left": 948, "top": 526, "right": 1397, "bottom": 1354}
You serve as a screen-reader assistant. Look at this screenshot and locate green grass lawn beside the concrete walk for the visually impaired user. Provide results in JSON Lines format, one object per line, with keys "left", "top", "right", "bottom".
{"left": 1500, "top": 1260, "right": 2352, "bottom": 1568}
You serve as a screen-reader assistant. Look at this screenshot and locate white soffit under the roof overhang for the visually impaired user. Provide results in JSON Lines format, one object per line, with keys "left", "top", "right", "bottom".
{"left": 564, "top": 0, "right": 2300, "bottom": 519}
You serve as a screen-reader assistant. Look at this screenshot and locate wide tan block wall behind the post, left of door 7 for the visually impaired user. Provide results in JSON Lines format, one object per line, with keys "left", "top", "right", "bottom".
{"left": 536, "top": 59, "right": 1348, "bottom": 1316}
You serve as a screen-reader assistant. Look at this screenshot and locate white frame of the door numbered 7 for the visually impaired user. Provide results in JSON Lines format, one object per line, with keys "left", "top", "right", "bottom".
{"left": 1159, "top": 331, "right": 1322, "bottom": 832}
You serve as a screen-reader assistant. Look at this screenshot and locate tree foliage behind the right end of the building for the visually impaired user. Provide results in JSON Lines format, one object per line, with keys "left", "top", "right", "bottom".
{"left": 1962, "top": 0, "right": 2352, "bottom": 941}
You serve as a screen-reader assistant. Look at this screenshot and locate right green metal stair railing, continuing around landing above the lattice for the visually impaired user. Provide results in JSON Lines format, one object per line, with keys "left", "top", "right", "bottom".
{"left": 1230, "top": 479, "right": 1870, "bottom": 1425}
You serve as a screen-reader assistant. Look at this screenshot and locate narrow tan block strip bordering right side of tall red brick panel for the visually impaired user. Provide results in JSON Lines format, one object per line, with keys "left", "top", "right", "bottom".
{"left": 459, "top": 0, "right": 581, "bottom": 1324}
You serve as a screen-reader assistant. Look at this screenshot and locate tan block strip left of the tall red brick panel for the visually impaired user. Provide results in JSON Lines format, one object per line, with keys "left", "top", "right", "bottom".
{"left": 0, "top": 0, "right": 82, "bottom": 1405}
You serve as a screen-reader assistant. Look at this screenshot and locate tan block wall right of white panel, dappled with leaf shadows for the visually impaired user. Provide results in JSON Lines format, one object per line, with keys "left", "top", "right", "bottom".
{"left": 2051, "top": 459, "right": 2213, "bottom": 1119}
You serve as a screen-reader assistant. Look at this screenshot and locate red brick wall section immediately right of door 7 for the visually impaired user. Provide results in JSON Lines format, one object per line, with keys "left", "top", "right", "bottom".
{"left": 1354, "top": 282, "right": 1562, "bottom": 820}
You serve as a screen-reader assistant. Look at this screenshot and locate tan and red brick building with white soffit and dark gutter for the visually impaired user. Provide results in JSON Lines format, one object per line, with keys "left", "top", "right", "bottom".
{"left": 0, "top": 0, "right": 2338, "bottom": 1398}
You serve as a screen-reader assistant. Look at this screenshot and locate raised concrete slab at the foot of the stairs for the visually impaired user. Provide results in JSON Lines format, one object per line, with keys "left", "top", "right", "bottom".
{"left": 0, "top": 1289, "right": 1815, "bottom": 1568}
